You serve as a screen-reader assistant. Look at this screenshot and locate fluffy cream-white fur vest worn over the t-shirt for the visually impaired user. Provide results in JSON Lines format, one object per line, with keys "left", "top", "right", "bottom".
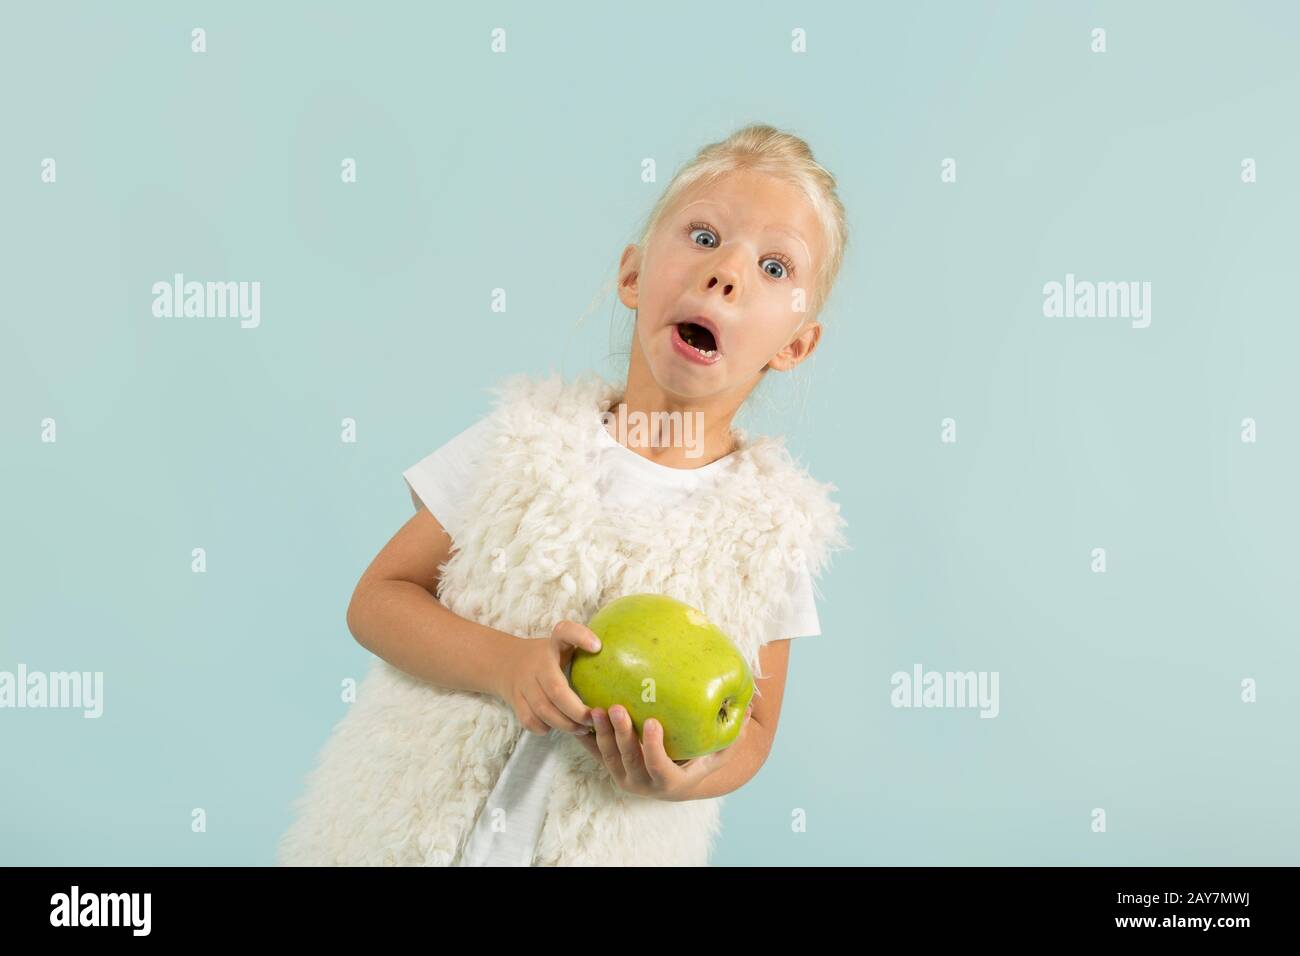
{"left": 278, "top": 372, "right": 845, "bottom": 866}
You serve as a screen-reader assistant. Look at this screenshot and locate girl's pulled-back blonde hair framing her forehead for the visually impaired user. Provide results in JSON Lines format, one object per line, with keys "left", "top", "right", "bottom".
{"left": 637, "top": 124, "right": 849, "bottom": 316}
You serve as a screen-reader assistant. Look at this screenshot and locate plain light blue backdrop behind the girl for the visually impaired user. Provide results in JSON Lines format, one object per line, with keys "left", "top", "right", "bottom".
{"left": 0, "top": 0, "right": 1300, "bottom": 865}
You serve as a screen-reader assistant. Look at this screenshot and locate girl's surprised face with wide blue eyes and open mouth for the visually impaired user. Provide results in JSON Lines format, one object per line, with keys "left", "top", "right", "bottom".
{"left": 619, "top": 170, "right": 823, "bottom": 399}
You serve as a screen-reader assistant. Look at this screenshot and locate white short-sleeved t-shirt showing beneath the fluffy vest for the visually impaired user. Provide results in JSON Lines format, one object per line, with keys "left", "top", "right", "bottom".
{"left": 402, "top": 418, "right": 822, "bottom": 866}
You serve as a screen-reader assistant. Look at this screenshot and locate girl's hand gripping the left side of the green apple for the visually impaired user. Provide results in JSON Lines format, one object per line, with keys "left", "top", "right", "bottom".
{"left": 498, "top": 620, "right": 601, "bottom": 736}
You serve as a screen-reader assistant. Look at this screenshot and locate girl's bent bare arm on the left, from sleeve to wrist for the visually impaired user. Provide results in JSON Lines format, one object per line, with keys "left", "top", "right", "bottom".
{"left": 347, "top": 507, "right": 521, "bottom": 698}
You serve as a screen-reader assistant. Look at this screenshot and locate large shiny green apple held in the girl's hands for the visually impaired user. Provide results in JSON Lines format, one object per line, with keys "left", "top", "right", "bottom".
{"left": 569, "top": 594, "right": 754, "bottom": 761}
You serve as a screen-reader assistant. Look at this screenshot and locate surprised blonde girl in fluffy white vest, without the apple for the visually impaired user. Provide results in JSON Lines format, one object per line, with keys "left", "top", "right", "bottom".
{"left": 280, "top": 125, "right": 848, "bottom": 865}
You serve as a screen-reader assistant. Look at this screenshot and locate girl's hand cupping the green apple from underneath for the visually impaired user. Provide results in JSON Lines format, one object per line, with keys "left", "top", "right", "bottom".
{"left": 579, "top": 701, "right": 754, "bottom": 800}
